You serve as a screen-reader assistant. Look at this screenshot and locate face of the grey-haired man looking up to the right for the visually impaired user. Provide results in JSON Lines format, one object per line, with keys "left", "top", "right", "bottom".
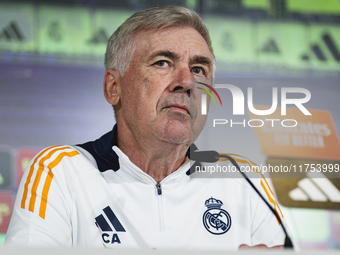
{"left": 120, "top": 27, "right": 214, "bottom": 144}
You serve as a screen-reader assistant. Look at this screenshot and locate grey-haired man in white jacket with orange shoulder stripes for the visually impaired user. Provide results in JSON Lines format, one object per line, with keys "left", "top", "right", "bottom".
{"left": 6, "top": 7, "right": 284, "bottom": 250}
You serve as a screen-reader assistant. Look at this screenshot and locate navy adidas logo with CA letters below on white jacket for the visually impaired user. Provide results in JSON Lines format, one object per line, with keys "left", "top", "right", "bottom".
{"left": 95, "top": 206, "right": 126, "bottom": 244}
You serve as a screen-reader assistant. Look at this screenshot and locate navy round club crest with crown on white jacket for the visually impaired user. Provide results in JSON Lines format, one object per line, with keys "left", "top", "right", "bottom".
{"left": 203, "top": 197, "right": 231, "bottom": 235}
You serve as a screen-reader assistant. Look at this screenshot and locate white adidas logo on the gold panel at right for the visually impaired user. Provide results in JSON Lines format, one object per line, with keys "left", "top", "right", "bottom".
{"left": 288, "top": 172, "right": 340, "bottom": 203}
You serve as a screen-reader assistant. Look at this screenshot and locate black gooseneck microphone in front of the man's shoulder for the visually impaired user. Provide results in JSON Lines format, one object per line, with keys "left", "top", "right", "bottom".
{"left": 189, "top": 150, "right": 293, "bottom": 248}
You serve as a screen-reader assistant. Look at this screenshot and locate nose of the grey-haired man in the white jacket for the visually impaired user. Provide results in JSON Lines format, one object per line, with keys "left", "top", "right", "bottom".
{"left": 170, "top": 66, "right": 193, "bottom": 96}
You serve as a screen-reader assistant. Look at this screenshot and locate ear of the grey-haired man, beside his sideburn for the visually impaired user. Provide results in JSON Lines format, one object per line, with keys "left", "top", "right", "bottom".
{"left": 104, "top": 70, "right": 121, "bottom": 105}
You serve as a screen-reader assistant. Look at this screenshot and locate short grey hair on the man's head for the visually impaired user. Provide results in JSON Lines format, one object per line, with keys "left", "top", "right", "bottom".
{"left": 104, "top": 6, "right": 214, "bottom": 75}
